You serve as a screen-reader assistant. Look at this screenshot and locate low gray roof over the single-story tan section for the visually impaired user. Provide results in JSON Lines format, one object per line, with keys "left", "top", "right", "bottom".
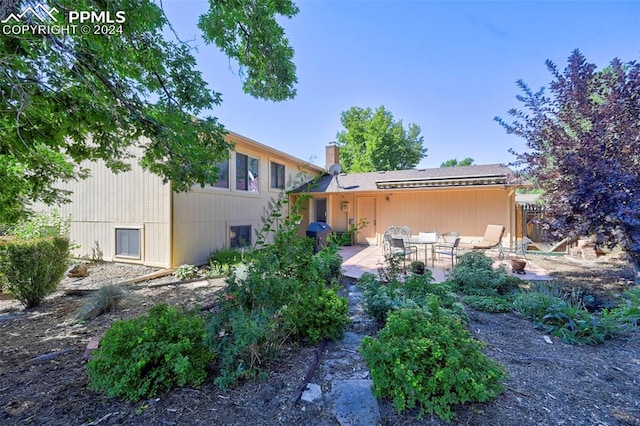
{"left": 294, "top": 164, "right": 513, "bottom": 193}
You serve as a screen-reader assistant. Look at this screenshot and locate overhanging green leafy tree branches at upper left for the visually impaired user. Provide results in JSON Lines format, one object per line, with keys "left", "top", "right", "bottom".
{"left": 0, "top": 0, "right": 298, "bottom": 223}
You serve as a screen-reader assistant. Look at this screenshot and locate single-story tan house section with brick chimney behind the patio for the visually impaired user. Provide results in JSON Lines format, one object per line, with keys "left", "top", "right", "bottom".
{"left": 297, "top": 145, "right": 516, "bottom": 247}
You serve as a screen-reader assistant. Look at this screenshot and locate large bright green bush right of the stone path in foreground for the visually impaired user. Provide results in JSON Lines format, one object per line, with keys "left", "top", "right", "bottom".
{"left": 360, "top": 299, "right": 506, "bottom": 420}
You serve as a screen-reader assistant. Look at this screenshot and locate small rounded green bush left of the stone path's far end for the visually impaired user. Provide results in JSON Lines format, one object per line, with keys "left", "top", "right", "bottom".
{"left": 282, "top": 283, "right": 350, "bottom": 343}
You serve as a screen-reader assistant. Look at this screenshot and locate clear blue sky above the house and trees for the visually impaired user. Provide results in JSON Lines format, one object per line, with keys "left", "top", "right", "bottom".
{"left": 158, "top": 0, "right": 640, "bottom": 167}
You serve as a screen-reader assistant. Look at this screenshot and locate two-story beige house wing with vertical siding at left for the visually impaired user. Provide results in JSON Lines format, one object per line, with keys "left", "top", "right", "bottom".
{"left": 48, "top": 132, "right": 323, "bottom": 267}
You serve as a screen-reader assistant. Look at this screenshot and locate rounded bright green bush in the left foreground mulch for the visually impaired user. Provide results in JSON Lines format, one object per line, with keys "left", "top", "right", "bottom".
{"left": 87, "top": 305, "right": 213, "bottom": 401}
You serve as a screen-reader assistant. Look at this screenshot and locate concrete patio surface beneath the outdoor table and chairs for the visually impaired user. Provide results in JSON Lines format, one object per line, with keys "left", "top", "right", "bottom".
{"left": 339, "top": 246, "right": 551, "bottom": 282}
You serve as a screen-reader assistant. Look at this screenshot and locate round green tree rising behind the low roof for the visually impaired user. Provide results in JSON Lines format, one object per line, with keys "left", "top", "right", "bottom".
{"left": 336, "top": 106, "right": 427, "bottom": 172}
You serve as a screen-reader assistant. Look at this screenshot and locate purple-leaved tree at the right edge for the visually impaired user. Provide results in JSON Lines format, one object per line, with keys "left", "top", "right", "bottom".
{"left": 496, "top": 50, "right": 640, "bottom": 284}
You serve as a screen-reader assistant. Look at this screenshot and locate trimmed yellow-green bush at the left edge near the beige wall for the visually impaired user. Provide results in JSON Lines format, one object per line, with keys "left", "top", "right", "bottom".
{"left": 0, "top": 237, "right": 69, "bottom": 308}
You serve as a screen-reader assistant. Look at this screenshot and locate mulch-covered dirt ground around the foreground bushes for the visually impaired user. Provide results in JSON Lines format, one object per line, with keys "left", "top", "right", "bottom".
{"left": 0, "top": 257, "right": 640, "bottom": 425}
